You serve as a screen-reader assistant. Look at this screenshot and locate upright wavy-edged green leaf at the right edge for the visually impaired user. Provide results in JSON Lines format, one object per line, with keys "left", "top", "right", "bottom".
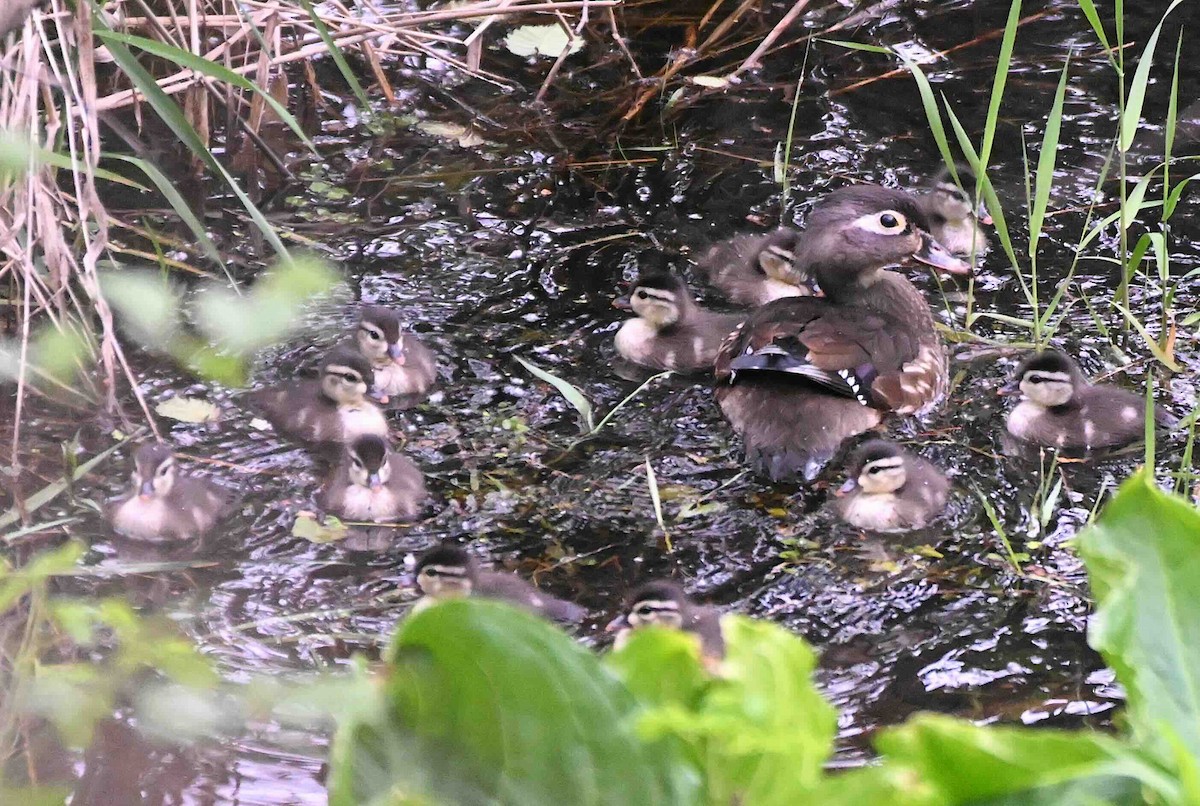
{"left": 1079, "top": 470, "right": 1200, "bottom": 756}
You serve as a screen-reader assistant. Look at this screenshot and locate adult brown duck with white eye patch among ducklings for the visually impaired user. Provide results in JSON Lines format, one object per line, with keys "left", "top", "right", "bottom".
{"left": 715, "top": 185, "right": 971, "bottom": 480}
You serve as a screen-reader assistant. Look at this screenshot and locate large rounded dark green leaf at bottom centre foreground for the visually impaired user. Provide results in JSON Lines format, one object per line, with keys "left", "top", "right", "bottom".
{"left": 329, "top": 600, "right": 695, "bottom": 806}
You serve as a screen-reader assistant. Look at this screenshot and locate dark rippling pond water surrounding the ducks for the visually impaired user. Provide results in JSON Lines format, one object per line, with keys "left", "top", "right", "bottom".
{"left": 2, "top": 0, "right": 1200, "bottom": 804}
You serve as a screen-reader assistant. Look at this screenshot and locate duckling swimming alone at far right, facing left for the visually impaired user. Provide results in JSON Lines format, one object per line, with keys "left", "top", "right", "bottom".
{"left": 1001, "top": 350, "right": 1172, "bottom": 450}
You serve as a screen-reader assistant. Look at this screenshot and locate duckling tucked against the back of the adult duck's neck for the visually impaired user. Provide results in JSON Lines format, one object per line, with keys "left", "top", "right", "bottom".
{"left": 696, "top": 227, "right": 815, "bottom": 307}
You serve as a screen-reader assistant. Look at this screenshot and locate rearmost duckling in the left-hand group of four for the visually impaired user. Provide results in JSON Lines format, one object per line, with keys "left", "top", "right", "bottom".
{"left": 354, "top": 305, "right": 438, "bottom": 403}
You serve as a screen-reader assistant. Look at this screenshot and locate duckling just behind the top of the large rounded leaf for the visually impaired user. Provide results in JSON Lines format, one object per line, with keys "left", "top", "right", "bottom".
{"left": 413, "top": 543, "right": 587, "bottom": 622}
